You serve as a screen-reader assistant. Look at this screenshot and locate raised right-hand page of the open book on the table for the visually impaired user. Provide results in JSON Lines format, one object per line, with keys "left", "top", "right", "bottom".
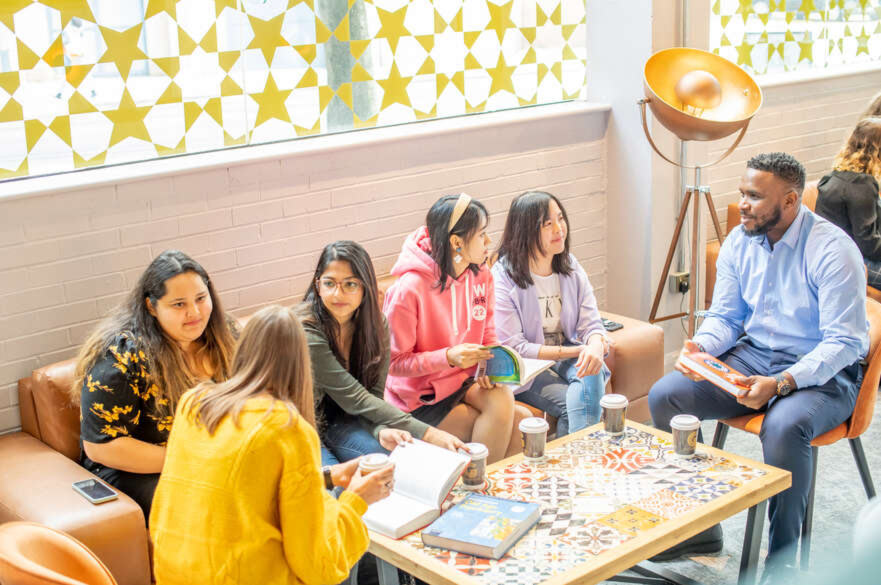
{"left": 390, "top": 440, "right": 470, "bottom": 508}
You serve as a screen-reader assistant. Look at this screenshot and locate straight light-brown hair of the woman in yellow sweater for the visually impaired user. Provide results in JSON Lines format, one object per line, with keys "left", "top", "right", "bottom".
{"left": 181, "top": 305, "right": 315, "bottom": 435}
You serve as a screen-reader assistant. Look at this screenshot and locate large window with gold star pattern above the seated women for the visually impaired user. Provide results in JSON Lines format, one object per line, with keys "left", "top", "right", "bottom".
{"left": 0, "top": 0, "right": 586, "bottom": 179}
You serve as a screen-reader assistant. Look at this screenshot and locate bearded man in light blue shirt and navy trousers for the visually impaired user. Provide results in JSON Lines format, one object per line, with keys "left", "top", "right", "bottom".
{"left": 649, "top": 152, "right": 869, "bottom": 580}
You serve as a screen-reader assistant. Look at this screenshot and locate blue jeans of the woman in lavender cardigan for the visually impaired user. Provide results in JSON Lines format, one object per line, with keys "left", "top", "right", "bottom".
{"left": 515, "top": 358, "right": 606, "bottom": 437}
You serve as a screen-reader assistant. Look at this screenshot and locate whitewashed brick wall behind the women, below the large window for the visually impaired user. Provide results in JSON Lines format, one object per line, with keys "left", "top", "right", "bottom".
{"left": 0, "top": 105, "right": 606, "bottom": 432}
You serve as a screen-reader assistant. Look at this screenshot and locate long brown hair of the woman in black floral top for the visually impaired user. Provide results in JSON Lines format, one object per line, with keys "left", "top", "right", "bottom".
{"left": 70, "top": 250, "right": 235, "bottom": 416}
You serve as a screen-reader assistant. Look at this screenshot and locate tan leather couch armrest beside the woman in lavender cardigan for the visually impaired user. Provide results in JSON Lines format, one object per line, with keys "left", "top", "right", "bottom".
{"left": 601, "top": 311, "right": 664, "bottom": 422}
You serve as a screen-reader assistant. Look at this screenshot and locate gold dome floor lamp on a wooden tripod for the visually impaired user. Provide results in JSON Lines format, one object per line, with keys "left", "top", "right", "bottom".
{"left": 639, "top": 48, "right": 762, "bottom": 337}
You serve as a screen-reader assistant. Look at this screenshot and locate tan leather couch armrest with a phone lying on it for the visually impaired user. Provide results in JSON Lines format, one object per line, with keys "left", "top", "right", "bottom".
{"left": 0, "top": 433, "right": 150, "bottom": 585}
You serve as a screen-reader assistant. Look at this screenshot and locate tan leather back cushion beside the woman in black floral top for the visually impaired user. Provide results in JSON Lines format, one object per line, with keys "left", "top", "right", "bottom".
{"left": 31, "top": 359, "right": 80, "bottom": 461}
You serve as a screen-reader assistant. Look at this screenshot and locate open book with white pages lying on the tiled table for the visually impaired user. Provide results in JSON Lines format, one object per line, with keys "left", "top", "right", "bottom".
{"left": 364, "top": 440, "right": 471, "bottom": 538}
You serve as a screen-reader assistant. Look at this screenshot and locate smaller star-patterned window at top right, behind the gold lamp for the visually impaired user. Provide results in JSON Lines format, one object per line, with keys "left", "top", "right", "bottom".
{"left": 710, "top": 0, "right": 881, "bottom": 75}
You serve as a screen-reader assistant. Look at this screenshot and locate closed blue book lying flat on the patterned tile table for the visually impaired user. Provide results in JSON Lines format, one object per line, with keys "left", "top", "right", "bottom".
{"left": 422, "top": 494, "right": 541, "bottom": 559}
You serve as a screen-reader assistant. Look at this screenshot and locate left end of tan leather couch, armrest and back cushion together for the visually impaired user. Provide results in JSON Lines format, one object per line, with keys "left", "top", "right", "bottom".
{"left": 0, "top": 360, "right": 150, "bottom": 585}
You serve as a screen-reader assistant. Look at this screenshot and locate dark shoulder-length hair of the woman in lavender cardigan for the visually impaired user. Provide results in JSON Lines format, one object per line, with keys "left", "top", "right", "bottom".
{"left": 499, "top": 191, "right": 572, "bottom": 288}
